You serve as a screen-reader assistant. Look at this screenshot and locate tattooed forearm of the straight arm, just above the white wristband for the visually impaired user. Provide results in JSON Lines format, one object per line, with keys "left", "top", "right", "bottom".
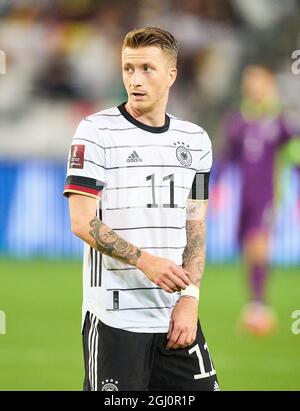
{"left": 182, "top": 220, "right": 206, "bottom": 287}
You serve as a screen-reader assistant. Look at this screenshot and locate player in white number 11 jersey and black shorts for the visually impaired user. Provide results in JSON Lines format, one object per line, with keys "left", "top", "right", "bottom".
{"left": 64, "top": 27, "right": 219, "bottom": 391}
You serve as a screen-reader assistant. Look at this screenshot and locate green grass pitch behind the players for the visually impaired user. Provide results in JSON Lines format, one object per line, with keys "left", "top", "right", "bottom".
{"left": 0, "top": 259, "right": 300, "bottom": 390}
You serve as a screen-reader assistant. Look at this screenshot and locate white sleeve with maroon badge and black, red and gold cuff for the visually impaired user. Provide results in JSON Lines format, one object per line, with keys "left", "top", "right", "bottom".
{"left": 63, "top": 119, "right": 106, "bottom": 198}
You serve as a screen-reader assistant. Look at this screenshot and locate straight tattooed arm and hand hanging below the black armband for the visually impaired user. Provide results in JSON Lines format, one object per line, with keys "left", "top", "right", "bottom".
{"left": 167, "top": 199, "right": 207, "bottom": 349}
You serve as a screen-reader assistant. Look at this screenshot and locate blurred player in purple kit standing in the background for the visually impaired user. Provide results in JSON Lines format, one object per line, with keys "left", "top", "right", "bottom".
{"left": 217, "top": 65, "right": 295, "bottom": 336}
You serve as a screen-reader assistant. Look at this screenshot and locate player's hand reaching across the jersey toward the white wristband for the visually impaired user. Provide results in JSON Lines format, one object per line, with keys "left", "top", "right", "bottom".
{"left": 136, "top": 251, "right": 190, "bottom": 293}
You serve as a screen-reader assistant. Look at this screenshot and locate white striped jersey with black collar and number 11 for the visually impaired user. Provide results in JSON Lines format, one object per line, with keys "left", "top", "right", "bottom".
{"left": 64, "top": 103, "right": 212, "bottom": 333}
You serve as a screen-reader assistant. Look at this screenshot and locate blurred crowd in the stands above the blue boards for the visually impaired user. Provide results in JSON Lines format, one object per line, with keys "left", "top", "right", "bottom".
{"left": 0, "top": 0, "right": 300, "bottom": 159}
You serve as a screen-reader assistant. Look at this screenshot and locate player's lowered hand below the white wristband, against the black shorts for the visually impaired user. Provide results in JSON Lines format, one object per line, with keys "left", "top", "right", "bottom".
{"left": 166, "top": 297, "right": 198, "bottom": 350}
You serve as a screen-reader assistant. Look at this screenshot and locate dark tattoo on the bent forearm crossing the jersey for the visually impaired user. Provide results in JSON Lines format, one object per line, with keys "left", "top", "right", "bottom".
{"left": 89, "top": 217, "right": 141, "bottom": 266}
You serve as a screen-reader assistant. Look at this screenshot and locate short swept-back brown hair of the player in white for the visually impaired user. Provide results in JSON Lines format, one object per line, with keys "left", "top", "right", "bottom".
{"left": 123, "top": 26, "right": 179, "bottom": 66}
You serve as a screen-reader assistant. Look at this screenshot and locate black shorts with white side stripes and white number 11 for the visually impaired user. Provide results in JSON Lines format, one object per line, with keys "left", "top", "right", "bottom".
{"left": 83, "top": 313, "right": 219, "bottom": 391}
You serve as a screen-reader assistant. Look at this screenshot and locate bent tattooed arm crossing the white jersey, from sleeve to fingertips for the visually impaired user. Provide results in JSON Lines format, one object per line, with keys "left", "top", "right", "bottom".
{"left": 69, "top": 194, "right": 190, "bottom": 292}
